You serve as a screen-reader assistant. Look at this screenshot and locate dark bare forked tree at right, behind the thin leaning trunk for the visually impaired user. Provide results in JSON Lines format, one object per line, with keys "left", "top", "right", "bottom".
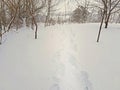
{"left": 95, "top": 0, "right": 120, "bottom": 28}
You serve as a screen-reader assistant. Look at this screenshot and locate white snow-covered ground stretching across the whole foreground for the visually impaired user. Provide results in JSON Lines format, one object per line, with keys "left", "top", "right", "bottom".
{"left": 0, "top": 24, "right": 120, "bottom": 90}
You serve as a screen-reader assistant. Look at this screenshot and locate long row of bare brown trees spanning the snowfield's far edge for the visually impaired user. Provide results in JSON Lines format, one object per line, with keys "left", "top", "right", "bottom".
{"left": 0, "top": 0, "right": 120, "bottom": 43}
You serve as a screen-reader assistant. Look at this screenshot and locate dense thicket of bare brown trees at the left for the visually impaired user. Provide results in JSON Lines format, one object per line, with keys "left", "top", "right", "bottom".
{"left": 0, "top": 0, "right": 46, "bottom": 44}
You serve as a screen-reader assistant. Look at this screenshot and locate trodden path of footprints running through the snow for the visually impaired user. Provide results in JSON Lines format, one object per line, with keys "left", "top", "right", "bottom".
{"left": 50, "top": 25, "right": 92, "bottom": 90}
